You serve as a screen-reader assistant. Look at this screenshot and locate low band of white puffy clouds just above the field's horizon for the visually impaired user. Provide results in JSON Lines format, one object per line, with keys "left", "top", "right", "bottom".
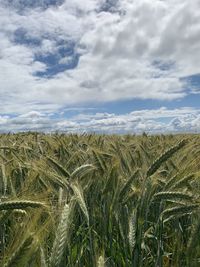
{"left": 0, "top": 107, "right": 200, "bottom": 134}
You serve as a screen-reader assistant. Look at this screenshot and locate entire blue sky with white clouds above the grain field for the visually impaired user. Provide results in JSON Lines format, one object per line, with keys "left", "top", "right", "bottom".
{"left": 0, "top": 0, "right": 200, "bottom": 134}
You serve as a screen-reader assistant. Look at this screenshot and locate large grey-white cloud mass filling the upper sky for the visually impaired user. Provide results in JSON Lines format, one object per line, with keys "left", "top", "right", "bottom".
{"left": 0, "top": 0, "right": 200, "bottom": 114}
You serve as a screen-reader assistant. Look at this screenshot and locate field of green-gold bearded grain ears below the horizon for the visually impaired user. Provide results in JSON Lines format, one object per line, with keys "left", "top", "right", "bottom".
{"left": 0, "top": 133, "right": 200, "bottom": 267}
